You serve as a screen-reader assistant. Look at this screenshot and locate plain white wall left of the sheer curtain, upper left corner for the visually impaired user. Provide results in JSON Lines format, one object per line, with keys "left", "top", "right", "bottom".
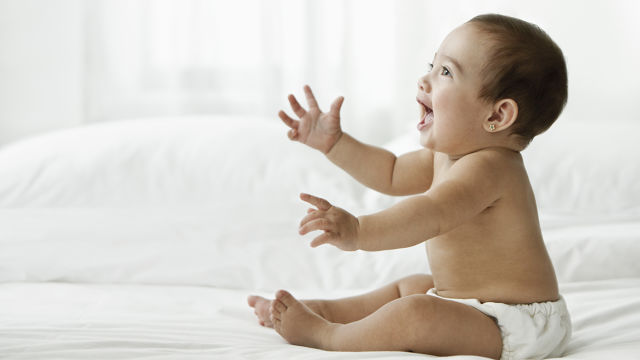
{"left": 0, "top": 0, "right": 84, "bottom": 144}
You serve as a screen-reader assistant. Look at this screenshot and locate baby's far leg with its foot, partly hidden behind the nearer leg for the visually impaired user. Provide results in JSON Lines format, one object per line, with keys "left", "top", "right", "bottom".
{"left": 247, "top": 274, "right": 434, "bottom": 327}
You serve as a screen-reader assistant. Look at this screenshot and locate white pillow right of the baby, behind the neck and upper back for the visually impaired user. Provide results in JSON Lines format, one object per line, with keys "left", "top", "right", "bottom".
{"left": 523, "top": 119, "right": 640, "bottom": 215}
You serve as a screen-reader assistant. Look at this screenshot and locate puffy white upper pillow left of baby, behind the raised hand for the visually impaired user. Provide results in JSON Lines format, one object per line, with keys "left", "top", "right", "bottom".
{"left": 0, "top": 117, "right": 362, "bottom": 207}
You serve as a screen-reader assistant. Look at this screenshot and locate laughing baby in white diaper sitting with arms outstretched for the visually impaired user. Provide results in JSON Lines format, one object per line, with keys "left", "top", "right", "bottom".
{"left": 248, "top": 15, "right": 571, "bottom": 359}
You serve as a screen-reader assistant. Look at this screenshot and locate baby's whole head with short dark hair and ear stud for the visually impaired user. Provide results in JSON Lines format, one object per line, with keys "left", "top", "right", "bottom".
{"left": 418, "top": 14, "right": 567, "bottom": 154}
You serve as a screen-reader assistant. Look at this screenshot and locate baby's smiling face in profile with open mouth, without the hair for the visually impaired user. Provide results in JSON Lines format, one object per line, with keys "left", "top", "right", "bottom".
{"left": 417, "top": 24, "right": 492, "bottom": 156}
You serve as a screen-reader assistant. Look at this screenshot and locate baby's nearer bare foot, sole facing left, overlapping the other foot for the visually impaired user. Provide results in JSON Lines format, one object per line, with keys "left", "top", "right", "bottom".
{"left": 271, "top": 290, "right": 331, "bottom": 349}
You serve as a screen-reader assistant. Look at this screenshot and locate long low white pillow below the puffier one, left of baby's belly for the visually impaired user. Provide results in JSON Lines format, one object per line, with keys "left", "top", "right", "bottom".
{"left": 0, "top": 205, "right": 428, "bottom": 291}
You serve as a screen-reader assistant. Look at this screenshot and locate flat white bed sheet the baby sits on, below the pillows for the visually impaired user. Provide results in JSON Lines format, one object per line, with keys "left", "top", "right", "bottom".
{"left": 0, "top": 279, "right": 640, "bottom": 359}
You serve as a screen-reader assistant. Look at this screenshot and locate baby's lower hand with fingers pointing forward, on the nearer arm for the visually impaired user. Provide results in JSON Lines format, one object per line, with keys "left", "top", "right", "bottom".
{"left": 299, "top": 193, "right": 360, "bottom": 251}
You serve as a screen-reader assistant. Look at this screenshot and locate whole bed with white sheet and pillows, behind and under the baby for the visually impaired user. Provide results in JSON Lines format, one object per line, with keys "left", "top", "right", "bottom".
{"left": 0, "top": 116, "right": 640, "bottom": 359}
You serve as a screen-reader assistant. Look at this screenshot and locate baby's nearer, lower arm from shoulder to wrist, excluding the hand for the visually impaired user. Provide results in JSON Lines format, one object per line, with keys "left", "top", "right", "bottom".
{"left": 358, "top": 153, "right": 505, "bottom": 251}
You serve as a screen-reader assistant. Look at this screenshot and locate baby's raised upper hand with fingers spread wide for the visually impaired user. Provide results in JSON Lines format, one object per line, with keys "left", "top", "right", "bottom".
{"left": 278, "top": 85, "right": 344, "bottom": 154}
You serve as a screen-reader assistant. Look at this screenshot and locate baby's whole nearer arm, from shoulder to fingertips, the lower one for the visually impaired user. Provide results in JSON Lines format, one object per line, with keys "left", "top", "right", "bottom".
{"left": 300, "top": 153, "right": 505, "bottom": 251}
